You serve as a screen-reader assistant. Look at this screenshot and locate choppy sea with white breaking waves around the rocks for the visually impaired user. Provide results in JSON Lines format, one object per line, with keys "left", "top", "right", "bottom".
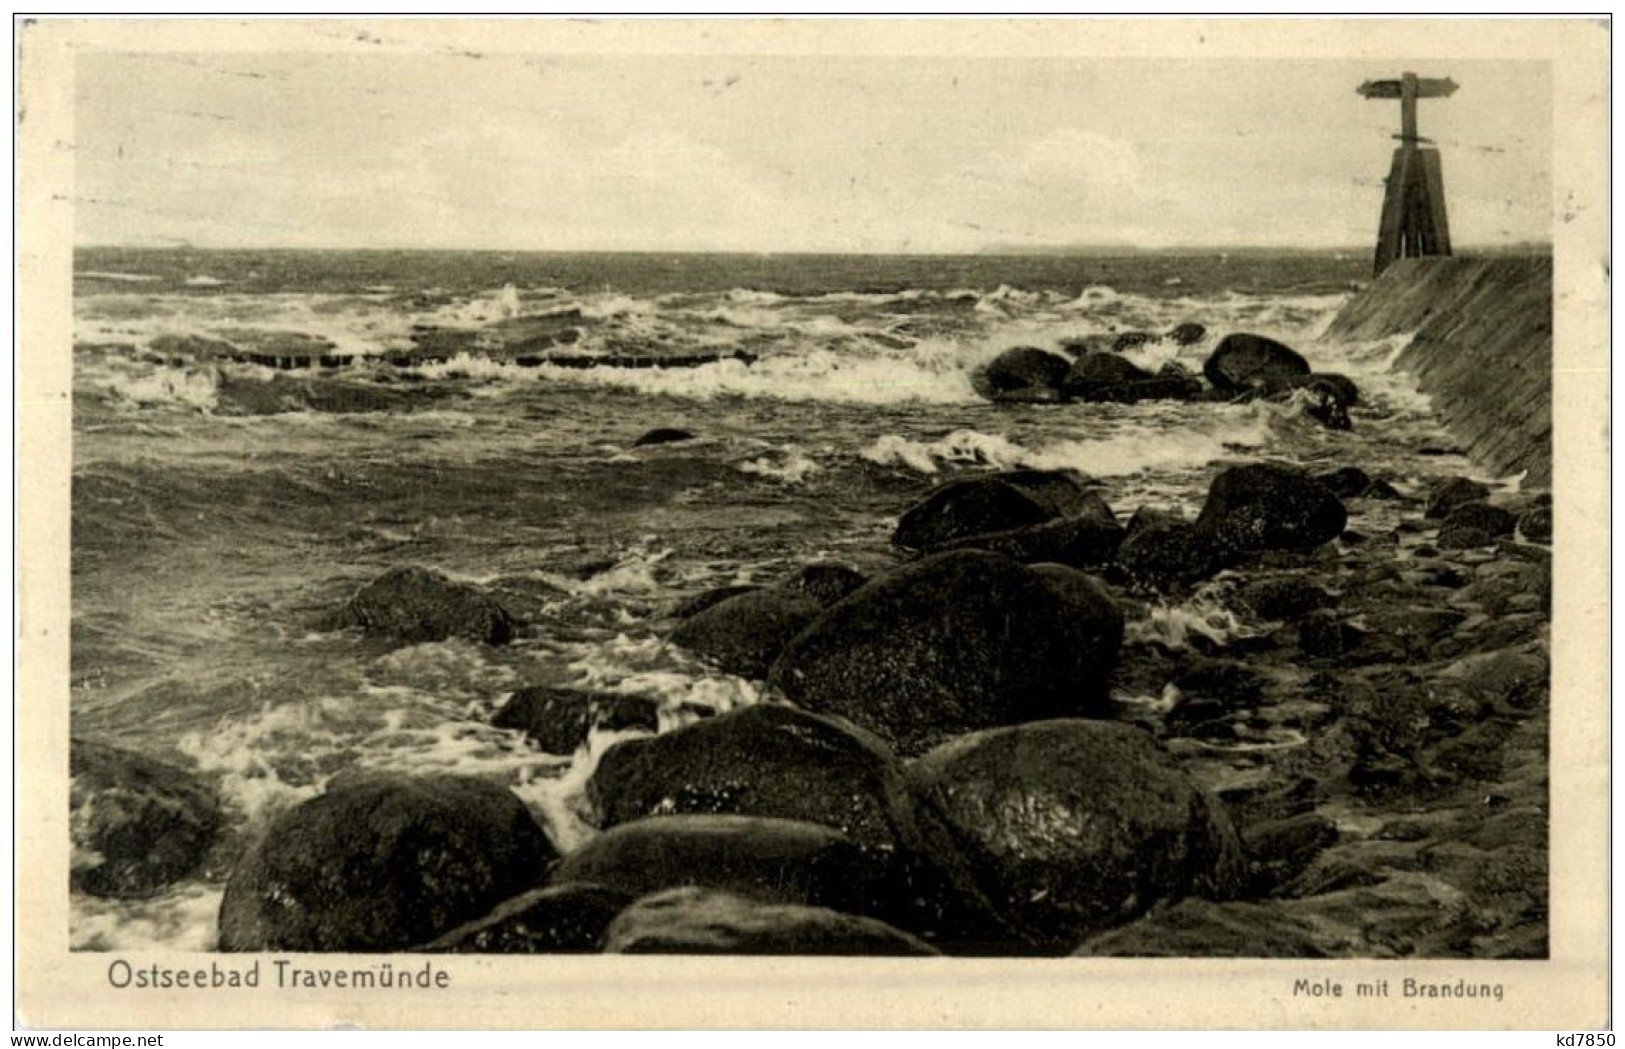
{"left": 72, "top": 248, "right": 1505, "bottom": 950}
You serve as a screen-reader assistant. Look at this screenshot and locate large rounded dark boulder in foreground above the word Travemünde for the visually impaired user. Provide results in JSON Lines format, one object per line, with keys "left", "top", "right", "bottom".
{"left": 219, "top": 775, "right": 554, "bottom": 952}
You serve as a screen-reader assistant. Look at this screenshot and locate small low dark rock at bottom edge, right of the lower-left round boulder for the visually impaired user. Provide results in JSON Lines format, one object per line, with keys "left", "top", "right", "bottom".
{"left": 416, "top": 882, "right": 632, "bottom": 955}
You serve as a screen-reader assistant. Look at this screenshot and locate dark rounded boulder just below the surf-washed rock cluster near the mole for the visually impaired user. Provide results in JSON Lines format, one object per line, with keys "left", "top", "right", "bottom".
{"left": 1196, "top": 463, "right": 1349, "bottom": 560}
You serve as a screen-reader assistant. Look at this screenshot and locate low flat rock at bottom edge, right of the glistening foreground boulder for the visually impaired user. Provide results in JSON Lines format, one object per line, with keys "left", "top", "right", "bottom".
{"left": 1073, "top": 896, "right": 1328, "bottom": 958}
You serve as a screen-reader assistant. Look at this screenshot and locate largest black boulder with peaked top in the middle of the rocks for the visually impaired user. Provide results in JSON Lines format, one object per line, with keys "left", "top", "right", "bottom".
{"left": 769, "top": 550, "right": 1123, "bottom": 755}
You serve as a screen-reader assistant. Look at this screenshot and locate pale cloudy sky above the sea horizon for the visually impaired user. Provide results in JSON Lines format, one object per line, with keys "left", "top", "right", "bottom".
{"left": 75, "top": 52, "right": 1552, "bottom": 252}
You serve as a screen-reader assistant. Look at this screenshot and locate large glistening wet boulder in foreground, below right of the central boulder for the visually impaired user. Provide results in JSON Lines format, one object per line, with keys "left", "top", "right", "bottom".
{"left": 908, "top": 719, "right": 1246, "bottom": 952}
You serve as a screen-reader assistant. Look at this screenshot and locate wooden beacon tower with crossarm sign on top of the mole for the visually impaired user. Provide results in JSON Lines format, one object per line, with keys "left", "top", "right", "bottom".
{"left": 1359, "top": 73, "right": 1456, "bottom": 276}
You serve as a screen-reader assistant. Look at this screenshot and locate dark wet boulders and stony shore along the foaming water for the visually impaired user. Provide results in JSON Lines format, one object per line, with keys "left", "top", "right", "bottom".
{"left": 72, "top": 330, "right": 1550, "bottom": 958}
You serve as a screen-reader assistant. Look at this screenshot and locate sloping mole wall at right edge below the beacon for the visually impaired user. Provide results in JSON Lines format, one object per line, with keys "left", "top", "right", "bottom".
{"left": 1326, "top": 257, "right": 1552, "bottom": 487}
